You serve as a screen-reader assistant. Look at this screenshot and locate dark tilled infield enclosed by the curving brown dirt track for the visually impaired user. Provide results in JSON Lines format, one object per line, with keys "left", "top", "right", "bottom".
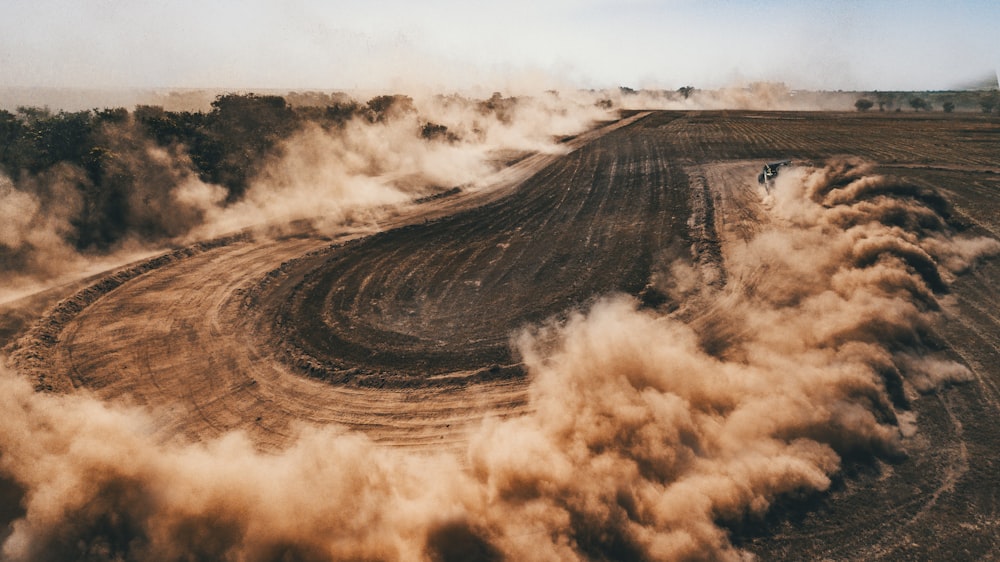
{"left": 255, "top": 116, "right": 688, "bottom": 386}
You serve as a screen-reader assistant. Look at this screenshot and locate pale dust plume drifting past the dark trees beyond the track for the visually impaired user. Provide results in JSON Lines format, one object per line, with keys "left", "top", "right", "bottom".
{"left": 0, "top": 92, "right": 611, "bottom": 302}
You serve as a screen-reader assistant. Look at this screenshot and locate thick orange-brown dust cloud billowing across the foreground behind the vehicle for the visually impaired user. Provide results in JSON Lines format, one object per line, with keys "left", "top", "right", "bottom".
{"left": 0, "top": 156, "right": 1000, "bottom": 561}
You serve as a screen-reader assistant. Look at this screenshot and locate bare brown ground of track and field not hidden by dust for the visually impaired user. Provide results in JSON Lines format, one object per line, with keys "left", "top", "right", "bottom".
{"left": 7, "top": 112, "right": 1000, "bottom": 559}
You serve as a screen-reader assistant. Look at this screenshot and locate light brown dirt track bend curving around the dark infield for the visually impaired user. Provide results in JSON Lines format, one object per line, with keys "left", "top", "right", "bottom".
{"left": 9, "top": 115, "right": 664, "bottom": 449}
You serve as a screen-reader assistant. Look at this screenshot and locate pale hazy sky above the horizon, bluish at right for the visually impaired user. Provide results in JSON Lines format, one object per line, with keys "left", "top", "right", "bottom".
{"left": 0, "top": 0, "right": 1000, "bottom": 90}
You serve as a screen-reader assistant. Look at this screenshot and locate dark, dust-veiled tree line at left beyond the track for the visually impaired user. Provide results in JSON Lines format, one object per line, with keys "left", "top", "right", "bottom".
{"left": 0, "top": 93, "right": 482, "bottom": 252}
